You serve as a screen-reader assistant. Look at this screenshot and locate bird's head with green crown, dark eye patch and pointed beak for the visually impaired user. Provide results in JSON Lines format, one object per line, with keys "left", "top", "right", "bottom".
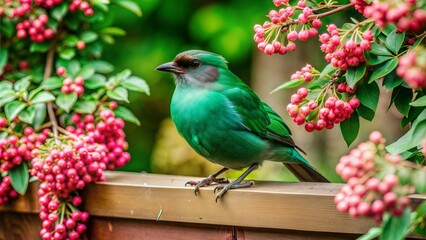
{"left": 156, "top": 50, "right": 228, "bottom": 86}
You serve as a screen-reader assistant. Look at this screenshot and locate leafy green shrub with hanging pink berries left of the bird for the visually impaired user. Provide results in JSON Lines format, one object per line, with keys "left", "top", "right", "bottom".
{"left": 0, "top": 0, "right": 149, "bottom": 239}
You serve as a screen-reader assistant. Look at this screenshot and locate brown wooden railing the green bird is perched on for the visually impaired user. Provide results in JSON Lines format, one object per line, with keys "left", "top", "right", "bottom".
{"left": 0, "top": 172, "right": 426, "bottom": 240}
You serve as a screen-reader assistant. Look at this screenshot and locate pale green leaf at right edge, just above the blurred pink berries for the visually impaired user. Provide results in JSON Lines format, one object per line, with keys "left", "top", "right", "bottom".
{"left": 386, "top": 109, "right": 426, "bottom": 154}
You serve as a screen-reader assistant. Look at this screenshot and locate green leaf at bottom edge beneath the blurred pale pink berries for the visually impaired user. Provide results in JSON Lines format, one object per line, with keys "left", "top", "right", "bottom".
{"left": 380, "top": 207, "right": 411, "bottom": 240}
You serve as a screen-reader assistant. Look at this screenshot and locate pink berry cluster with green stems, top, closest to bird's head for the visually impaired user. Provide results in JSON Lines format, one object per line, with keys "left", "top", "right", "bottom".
{"left": 254, "top": 0, "right": 322, "bottom": 55}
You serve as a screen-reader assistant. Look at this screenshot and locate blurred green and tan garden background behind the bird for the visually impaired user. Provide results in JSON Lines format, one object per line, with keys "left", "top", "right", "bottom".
{"left": 104, "top": 0, "right": 401, "bottom": 181}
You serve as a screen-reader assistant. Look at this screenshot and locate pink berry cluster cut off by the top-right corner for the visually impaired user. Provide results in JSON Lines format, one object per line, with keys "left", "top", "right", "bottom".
{"left": 361, "top": 0, "right": 426, "bottom": 33}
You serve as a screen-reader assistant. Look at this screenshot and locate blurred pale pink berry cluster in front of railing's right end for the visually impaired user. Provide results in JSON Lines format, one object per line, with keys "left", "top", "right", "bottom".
{"left": 334, "top": 131, "right": 414, "bottom": 222}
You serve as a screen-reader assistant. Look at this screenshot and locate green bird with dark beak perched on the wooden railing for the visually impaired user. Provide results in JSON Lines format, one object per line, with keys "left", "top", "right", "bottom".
{"left": 156, "top": 50, "right": 328, "bottom": 201}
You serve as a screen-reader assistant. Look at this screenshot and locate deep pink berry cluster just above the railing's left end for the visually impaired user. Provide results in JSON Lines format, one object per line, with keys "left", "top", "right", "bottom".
{"left": 67, "top": 109, "right": 130, "bottom": 170}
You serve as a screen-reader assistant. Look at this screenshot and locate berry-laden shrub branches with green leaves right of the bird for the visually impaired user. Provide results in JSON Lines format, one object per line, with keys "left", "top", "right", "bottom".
{"left": 254, "top": 0, "right": 426, "bottom": 239}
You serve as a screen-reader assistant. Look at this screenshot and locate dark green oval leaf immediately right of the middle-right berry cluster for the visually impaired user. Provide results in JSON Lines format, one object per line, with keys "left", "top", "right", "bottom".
{"left": 355, "top": 80, "right": 380, "bottom": 111}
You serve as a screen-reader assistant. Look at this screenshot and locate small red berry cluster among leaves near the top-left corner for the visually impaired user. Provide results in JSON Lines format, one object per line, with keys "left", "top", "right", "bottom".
{"left": 16, "top": 14, "right": 53, "bottom": 42}
